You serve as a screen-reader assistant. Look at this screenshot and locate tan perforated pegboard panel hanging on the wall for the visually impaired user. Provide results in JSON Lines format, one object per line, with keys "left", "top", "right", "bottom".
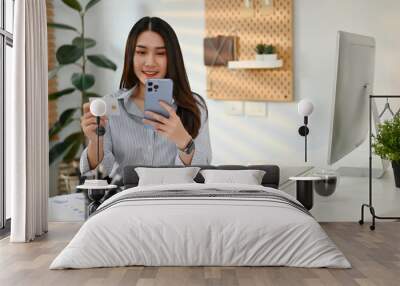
{"left": 205, "top": 0, "right": 293, "bottom": 101}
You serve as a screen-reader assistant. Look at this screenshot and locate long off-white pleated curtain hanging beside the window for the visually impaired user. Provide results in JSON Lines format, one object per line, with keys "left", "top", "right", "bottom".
{"left": 6, "top": 0, "right": 49, "bottom": 242}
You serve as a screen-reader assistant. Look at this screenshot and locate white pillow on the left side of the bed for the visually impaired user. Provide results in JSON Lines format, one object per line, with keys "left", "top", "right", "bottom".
{"left": 135, "top": 167, "right": 200, "bottom": 186}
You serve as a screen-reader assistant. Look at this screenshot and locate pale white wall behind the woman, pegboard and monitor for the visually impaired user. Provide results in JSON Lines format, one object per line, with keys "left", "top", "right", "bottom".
{"left": 55, "top": 0, "right": 400, "bottom": 170}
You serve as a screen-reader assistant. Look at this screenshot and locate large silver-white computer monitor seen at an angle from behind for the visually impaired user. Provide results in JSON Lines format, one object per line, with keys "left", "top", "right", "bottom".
{"left": 328, "top": 31, "right": 388, "bottom": 175}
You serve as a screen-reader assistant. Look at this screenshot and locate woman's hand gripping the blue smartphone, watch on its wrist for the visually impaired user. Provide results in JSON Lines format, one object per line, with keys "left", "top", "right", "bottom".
{"left": 143, "top": 101, "right": 192, "bottom": 149}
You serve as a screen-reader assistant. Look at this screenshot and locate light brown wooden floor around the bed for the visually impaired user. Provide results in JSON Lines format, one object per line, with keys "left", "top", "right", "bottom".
{"left": 0, "top": 222, "right": 400, "bottom": 286}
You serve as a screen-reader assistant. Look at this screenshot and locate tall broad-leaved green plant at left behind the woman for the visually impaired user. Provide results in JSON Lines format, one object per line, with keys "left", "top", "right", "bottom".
{"left": 47, "top": 0, "right": 117, "bottom": 164}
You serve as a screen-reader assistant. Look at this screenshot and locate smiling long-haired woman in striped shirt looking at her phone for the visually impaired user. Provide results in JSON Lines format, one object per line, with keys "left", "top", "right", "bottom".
{"left": 80, "top": 17, "right": 211, "bottom": 177}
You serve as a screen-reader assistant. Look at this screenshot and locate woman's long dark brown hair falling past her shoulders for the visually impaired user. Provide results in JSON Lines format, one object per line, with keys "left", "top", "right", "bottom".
{"left": 119, "top": 17, "right": 208, "bottom": 138}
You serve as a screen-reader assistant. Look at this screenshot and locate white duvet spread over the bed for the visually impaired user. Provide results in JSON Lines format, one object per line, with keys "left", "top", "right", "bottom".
{"left": 50, "top": 183, "right": 351, "bottom": 269}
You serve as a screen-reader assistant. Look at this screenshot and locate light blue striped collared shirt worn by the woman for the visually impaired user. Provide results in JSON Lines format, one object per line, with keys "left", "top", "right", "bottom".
{"left": 80, "top": 88, "right": 211, "bottom": 177}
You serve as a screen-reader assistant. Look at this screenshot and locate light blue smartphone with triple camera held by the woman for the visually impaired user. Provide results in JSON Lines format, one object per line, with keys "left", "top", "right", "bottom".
{"left": 144, "top": 78, "right": 174, "bottom": 128}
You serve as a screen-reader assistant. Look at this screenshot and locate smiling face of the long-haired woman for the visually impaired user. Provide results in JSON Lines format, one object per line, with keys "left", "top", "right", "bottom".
{"left": 133, "top": 31, "right": 167, "bottom": 84}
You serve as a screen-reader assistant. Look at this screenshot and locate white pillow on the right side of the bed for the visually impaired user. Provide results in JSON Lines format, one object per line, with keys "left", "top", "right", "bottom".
{"left": 200, "top": 170, "right": 265, "bottom": 185}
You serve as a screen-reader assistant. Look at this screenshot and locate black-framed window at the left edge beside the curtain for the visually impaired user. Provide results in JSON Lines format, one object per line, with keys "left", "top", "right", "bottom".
{"left": 0, "top": 0, "right": 14, "bottom": 232}
